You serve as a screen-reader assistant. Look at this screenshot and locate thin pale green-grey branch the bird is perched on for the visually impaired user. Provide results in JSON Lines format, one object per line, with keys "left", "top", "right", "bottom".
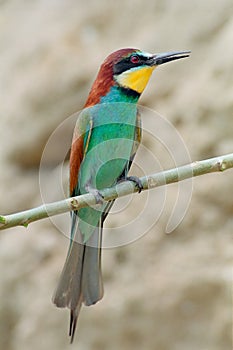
{"left": 0, "top": 153, "right": 233, "bottom": 230}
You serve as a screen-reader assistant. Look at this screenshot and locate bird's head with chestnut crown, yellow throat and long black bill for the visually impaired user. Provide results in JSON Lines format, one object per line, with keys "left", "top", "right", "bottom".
{"left": 86, "top": 48, "right": 190, "bottom": 106}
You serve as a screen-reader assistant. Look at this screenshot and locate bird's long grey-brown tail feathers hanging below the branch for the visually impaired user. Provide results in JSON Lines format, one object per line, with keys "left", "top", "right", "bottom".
{"left": 53, "top": 220, "right": 103, "bottom": 343}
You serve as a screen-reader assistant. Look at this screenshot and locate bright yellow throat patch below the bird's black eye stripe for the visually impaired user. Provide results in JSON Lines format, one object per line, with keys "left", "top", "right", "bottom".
{"left": 116, "top": 66, "right": 155, "bottom": 94}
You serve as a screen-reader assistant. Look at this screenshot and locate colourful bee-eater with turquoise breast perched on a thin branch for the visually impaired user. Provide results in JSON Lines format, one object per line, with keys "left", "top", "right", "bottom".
{"left": 53, "top": 48, "right": 190, "bottom": 342}
